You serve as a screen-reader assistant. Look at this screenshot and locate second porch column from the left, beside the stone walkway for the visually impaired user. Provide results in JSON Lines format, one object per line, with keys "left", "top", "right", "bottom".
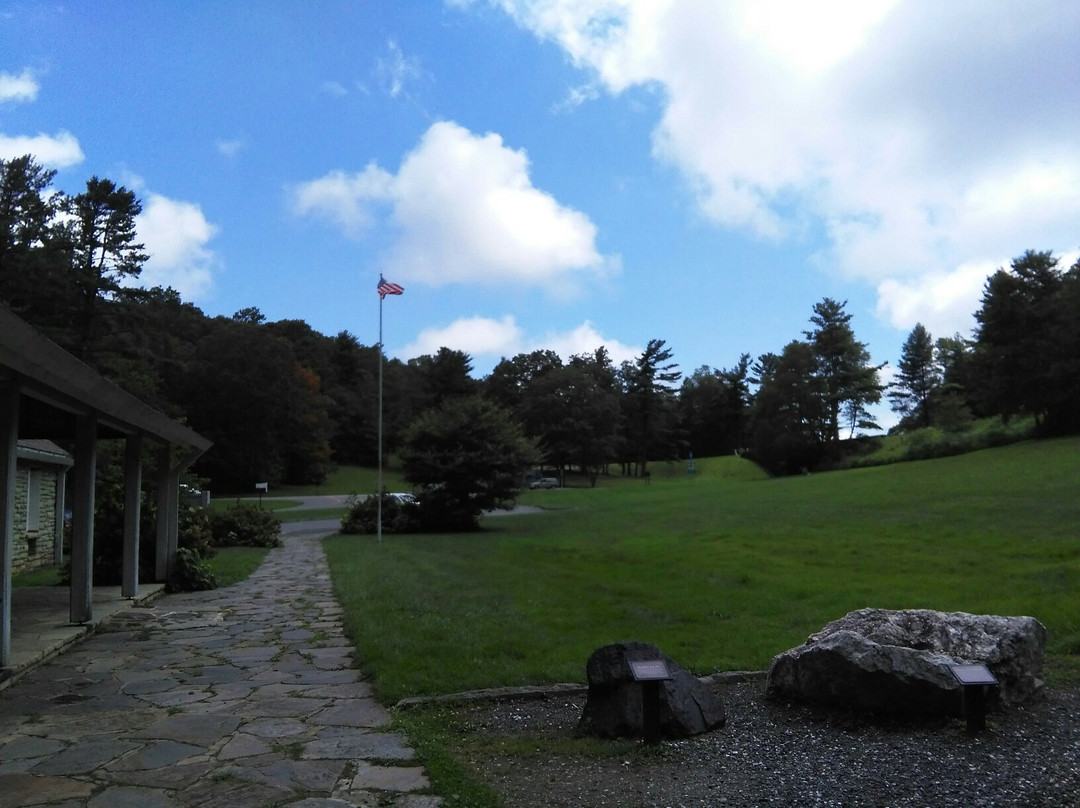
{"left": 70, "top": 414, "right": 97, "bottom": 623}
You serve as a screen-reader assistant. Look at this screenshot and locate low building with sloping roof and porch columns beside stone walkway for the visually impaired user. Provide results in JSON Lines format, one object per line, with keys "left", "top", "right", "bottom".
{"left": 0, "top": 306, "right": 211, "bottom": 669}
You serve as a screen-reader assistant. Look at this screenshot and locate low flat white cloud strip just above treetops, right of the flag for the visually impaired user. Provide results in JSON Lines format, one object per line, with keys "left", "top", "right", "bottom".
{"left": 397, "top": 314, "right": 642, "bottom": 365}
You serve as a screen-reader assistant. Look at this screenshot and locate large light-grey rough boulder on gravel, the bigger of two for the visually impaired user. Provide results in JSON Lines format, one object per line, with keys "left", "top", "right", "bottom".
{"left": 766, "top": 609, "right": 1047, "bottom": 715}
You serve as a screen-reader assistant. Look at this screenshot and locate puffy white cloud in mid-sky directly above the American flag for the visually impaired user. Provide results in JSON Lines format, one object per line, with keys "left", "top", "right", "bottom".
{"left": 293, "top": 121, "right": 618, "bottom": 294}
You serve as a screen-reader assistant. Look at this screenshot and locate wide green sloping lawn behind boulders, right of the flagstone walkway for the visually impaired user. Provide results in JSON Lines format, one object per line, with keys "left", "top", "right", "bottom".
{"left": 326, "top": 439, "right": 1080, "bottom": 702}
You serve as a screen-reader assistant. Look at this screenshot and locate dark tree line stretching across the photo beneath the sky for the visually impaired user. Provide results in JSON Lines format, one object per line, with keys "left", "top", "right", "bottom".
{"left": 0, "top": 157, "right": 1080, "bottom": 491}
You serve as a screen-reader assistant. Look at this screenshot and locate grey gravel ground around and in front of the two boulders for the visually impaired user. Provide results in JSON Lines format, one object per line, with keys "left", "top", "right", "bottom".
{"left": 444, "top": 681, "right": 1080, "bottom": 808}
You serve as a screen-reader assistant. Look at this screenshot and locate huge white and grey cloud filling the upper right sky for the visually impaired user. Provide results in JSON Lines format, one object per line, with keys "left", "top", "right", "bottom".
{"left": 489, "top": 0, "right": 1080, "bottom": 328}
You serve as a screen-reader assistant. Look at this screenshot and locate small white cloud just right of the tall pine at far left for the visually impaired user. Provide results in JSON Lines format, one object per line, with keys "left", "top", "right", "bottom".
{"left": 136, "top": 193, "right": 217, "bottom": 299}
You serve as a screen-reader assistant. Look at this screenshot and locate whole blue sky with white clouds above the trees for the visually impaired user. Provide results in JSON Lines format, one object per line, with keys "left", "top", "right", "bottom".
{"left": 0, "top": 0, "right": 1080, "bottom": 426}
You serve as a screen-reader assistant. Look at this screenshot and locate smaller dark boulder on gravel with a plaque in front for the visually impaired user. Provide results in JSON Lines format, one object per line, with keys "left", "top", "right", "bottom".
{"left": 578, "top": 643, "right": 727, "bottom": 739}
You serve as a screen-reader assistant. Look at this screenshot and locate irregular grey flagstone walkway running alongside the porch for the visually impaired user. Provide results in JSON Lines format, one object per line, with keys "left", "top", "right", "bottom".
{"left": 0, "top": 528, "right": 441, "bottom": 808}
